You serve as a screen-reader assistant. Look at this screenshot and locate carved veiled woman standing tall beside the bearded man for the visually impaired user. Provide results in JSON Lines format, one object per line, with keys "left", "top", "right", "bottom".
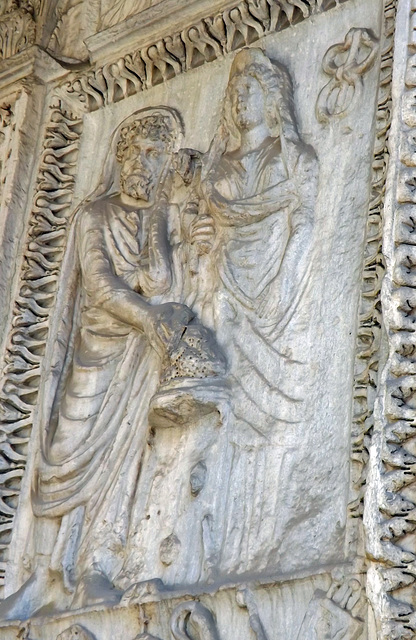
{"left": 189, "top": 49, "right": 317, "bottom": 573}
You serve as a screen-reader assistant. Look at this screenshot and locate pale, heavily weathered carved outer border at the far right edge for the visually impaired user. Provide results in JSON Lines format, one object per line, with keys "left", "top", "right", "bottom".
{"left": 365, "top": 2, "right": 416, "bottom": 640}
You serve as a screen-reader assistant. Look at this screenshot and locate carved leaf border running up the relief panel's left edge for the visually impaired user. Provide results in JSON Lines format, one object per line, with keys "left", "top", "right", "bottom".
{"left": 0, "top": 100, "right": 82, "bottom": 584}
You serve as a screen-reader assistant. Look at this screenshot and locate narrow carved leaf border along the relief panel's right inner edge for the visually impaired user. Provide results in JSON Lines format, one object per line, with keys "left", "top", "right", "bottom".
{"left": 348, "top": 0, "right": 397, "bottom": 549}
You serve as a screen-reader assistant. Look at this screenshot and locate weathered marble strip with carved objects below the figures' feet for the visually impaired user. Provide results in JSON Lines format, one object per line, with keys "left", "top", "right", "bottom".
{"left": 0, "top": 574, "right": 363, "bottom": 640}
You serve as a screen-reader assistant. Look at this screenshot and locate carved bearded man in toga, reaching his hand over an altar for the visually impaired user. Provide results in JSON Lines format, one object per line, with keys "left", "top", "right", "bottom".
{"left": 0, "top": 107, "right": 228, "bottom": 618}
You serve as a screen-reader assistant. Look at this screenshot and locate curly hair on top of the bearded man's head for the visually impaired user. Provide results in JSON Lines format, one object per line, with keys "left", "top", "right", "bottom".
{"left": 116, "top": 114, "right": 175, "bottom": 162}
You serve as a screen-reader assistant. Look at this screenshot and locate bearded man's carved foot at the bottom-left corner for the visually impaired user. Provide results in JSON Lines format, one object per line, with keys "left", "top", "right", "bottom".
{"left": 0, "top": 567, "right": 53, "bottom": 620}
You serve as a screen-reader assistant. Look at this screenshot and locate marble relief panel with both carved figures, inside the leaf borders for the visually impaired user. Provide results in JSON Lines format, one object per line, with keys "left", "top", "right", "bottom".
{"left": 0, "top": 0, "right": 382, "bottom": 640}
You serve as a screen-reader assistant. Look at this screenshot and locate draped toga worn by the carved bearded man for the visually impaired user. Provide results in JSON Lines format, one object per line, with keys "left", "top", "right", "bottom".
{"left": 34, "top": 199, "right": 160, "bottom": 582}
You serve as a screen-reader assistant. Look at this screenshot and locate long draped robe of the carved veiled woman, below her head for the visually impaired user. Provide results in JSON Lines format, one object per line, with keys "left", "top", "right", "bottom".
{"left": 189, "top": 138, "right": 317, "bottom": 575}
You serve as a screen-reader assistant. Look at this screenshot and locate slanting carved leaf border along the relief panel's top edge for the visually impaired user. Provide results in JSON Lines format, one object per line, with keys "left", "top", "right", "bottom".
{"left": 63, "top": 0, "right": 354, "bottom": 112}
